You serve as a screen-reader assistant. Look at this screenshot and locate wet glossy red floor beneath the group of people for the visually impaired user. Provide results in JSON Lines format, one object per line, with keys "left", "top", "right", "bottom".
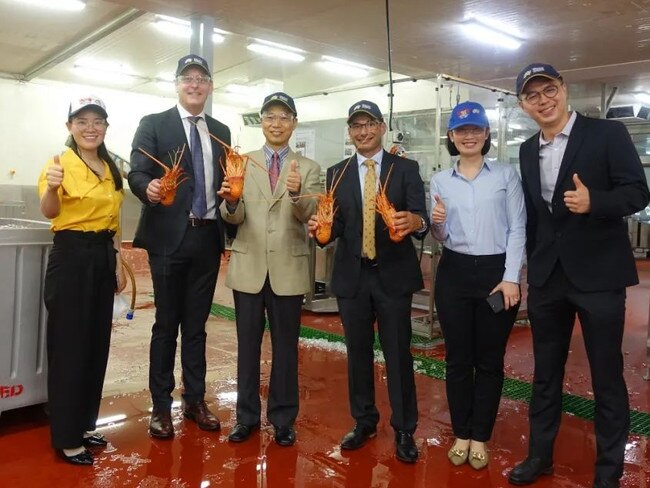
{"left": 0, "top": 250, "right": 650, "bottom": 488}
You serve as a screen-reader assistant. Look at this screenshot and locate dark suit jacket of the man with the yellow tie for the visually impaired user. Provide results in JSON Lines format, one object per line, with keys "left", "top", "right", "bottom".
{"left": 327, "top": 151, "right": 429, "bottom": 298}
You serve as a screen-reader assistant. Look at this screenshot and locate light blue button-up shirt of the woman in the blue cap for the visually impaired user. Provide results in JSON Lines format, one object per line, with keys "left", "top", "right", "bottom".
{"left": 430, "top": 160, "right": 526, "bottom": 283}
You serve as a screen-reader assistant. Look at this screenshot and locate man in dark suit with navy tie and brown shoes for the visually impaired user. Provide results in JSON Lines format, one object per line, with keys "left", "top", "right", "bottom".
{"left": 128, "top": 54, "right": 230, "bottom": 438}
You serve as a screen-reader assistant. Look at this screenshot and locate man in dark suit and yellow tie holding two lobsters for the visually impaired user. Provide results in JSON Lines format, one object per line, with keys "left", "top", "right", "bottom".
{"left": 309, "top": 100, "right": 429, "bottom": 463}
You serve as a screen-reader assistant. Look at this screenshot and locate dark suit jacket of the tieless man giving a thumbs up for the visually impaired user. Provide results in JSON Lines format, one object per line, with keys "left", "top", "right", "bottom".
{"left": 519, "top": 114, "right": 650, "bottom": 292}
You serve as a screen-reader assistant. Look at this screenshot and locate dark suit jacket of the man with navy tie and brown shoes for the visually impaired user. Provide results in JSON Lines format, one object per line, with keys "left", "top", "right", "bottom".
{"left": 128, "top": 107, "right": 230, "bottom": 254}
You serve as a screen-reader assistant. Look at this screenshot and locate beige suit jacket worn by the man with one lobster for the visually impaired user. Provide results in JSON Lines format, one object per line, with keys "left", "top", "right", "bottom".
{"left": 220, "top": 150, "right": 321, "bottom": 296}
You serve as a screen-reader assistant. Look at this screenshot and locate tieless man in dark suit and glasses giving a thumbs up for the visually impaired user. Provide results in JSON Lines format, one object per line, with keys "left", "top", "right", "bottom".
{"left": 508, "top": 63, "right": 649, "bottom": 488}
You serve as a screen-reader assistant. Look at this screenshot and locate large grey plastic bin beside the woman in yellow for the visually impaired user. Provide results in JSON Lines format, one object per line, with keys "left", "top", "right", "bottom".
{"left": 0, "top": 218, "right": 53, "bottom": 414}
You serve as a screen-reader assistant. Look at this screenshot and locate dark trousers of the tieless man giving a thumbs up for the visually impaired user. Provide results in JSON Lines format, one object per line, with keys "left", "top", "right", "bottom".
{"left": 528, "top": 264, "right": 630, "bottom": 480}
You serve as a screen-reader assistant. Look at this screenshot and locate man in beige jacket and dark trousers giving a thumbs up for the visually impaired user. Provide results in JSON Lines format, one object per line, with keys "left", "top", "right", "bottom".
{"left": 219, "top": 92, "right": 321, "bottom": 446}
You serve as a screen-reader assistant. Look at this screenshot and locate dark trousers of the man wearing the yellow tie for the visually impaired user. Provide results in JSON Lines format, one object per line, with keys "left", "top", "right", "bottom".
{"left": 337, "top": 265, "right": 418, "bottom": 433}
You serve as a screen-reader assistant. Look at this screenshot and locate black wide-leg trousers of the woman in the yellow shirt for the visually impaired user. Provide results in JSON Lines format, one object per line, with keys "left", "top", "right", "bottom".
{"left": 44, "top": 231, "right": 117, "bottom": 449}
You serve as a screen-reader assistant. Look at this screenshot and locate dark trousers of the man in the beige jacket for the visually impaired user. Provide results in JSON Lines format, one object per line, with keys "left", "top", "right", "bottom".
{"left": 233, "top": 276, "right": 303, "bottom": 427}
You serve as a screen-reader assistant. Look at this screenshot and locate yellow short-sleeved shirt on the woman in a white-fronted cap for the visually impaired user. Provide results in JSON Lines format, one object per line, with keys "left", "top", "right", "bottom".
{"left": 38, "top": 149, "right": 124, "bottom": 232}
